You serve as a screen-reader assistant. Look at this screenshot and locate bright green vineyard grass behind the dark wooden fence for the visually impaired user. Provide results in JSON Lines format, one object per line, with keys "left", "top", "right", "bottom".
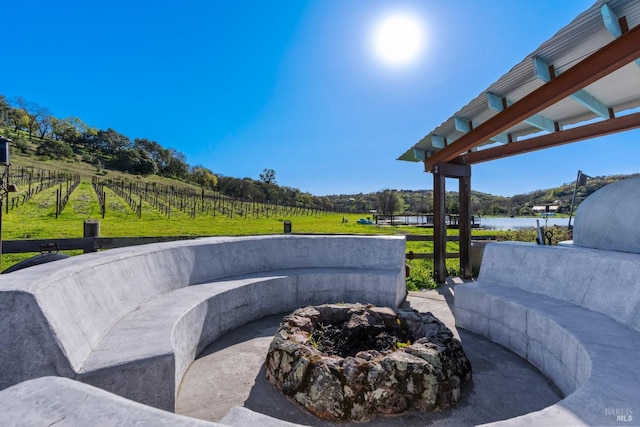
{"left": 2, "top": 175, "right": 470, "bottom": 289}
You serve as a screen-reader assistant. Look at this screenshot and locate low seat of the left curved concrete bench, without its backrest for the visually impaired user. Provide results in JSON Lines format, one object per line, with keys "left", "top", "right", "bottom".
{"left": 75, "top": 268, "right": 395, "bottom": 409}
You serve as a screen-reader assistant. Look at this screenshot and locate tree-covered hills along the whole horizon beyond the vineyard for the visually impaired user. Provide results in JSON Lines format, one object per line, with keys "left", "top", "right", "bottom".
{"left": 0, "top": 94, "right": 640, "bottom": 216}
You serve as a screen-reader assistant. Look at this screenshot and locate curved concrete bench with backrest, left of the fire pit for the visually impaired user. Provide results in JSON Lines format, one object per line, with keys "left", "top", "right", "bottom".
{"left": 0, "top": 236, "right": 406, "bottom": 411}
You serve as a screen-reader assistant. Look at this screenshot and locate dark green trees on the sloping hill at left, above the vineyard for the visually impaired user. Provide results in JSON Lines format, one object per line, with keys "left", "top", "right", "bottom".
{"left": 0, "top": 95, "right": 333, "bottom": 210}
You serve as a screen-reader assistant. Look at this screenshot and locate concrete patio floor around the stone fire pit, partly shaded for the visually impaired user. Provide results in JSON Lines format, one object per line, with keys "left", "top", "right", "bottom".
{"left": 176, "top": 279, "right": 562, "bottom": 426}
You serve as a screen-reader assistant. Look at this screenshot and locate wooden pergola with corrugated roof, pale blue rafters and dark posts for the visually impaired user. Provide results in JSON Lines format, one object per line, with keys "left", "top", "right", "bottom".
{"left": 399, "top": 0, "right": 640, "bottom": 282}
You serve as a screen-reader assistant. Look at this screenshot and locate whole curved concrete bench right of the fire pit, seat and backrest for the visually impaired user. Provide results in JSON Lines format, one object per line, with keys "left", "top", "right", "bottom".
{"left": 455, "top": 242, "right": 640, "bottom": 425}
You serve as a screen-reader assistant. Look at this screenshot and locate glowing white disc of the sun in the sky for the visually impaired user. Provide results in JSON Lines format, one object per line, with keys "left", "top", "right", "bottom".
{"left": 372, "top": 13, "right": 424, "bottom": 66}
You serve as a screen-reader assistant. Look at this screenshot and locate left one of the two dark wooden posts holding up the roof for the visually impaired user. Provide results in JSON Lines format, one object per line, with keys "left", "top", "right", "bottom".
{"left": 433, "top": 169, "right": 447, "bottom": 283}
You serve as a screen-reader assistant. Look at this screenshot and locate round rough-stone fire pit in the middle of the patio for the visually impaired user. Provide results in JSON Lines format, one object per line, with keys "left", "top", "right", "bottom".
{"left": 266, "top": 304, "right": 471, "bottom": 422}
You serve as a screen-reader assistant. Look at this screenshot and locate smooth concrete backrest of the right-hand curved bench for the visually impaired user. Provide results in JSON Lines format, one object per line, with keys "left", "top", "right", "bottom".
{"left": 478, "top": 242, "right": 640, "bottom": 331}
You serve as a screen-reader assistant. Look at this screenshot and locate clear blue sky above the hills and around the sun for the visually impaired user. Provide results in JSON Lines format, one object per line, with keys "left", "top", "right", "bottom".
{"left": 0, "top": 0, "right": 640, "bottom": 195}
